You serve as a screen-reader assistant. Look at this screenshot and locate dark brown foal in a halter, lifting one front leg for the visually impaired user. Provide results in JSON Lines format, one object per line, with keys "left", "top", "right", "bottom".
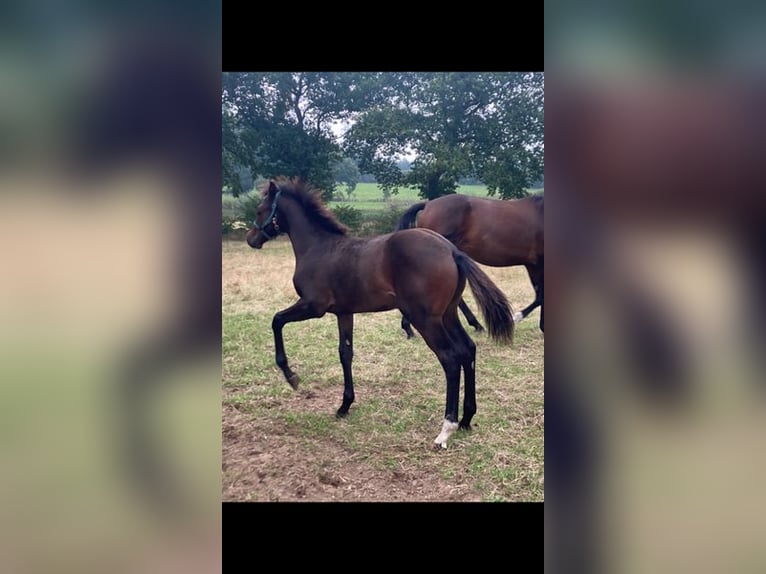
{"left": 247, "top": 178, "right": 514, "bottom": 448}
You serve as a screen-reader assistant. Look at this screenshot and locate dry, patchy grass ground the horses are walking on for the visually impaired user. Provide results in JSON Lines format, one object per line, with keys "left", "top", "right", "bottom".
{"left": 222, "top": 238, "right": 544, "bottom": 501}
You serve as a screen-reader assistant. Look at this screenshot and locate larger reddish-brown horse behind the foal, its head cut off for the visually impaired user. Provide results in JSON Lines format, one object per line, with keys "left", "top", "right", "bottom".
{"left": 397, "top": 194, "right": 544, "bottom": 338}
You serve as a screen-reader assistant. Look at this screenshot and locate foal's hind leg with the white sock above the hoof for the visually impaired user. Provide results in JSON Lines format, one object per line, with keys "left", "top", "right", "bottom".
{"left": 413, "top": 317, "right": 462, "bottom": 449}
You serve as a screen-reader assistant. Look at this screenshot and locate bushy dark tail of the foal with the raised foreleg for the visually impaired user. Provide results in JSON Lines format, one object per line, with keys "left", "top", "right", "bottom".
{"left": 452, "top": 248, "right": 514, "bottom": 343}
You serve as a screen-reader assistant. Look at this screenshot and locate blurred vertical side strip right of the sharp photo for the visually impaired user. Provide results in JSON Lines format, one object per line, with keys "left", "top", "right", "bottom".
{"left": 545, "top": 2, "right": 766, "bottom": 573}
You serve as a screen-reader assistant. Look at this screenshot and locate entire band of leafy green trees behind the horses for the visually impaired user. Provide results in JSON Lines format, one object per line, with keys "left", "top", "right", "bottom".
{"left": 222, "top": 72, "right": 544, "bottom": 198}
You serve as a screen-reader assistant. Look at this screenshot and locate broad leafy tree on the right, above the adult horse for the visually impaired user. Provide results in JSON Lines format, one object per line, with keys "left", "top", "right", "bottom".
{"left": 344, "top": 72, "right": 544, "bottom": 199}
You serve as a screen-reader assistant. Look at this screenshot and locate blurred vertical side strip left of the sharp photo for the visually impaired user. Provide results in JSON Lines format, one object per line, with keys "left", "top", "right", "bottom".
{"left": 0, "top": 0, "right": 221, "bottom": 572}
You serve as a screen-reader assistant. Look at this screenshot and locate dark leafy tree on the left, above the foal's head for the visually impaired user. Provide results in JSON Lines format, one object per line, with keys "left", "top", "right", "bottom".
{"left": 222, "top": 72, "right": 378, "bottom": 198}
